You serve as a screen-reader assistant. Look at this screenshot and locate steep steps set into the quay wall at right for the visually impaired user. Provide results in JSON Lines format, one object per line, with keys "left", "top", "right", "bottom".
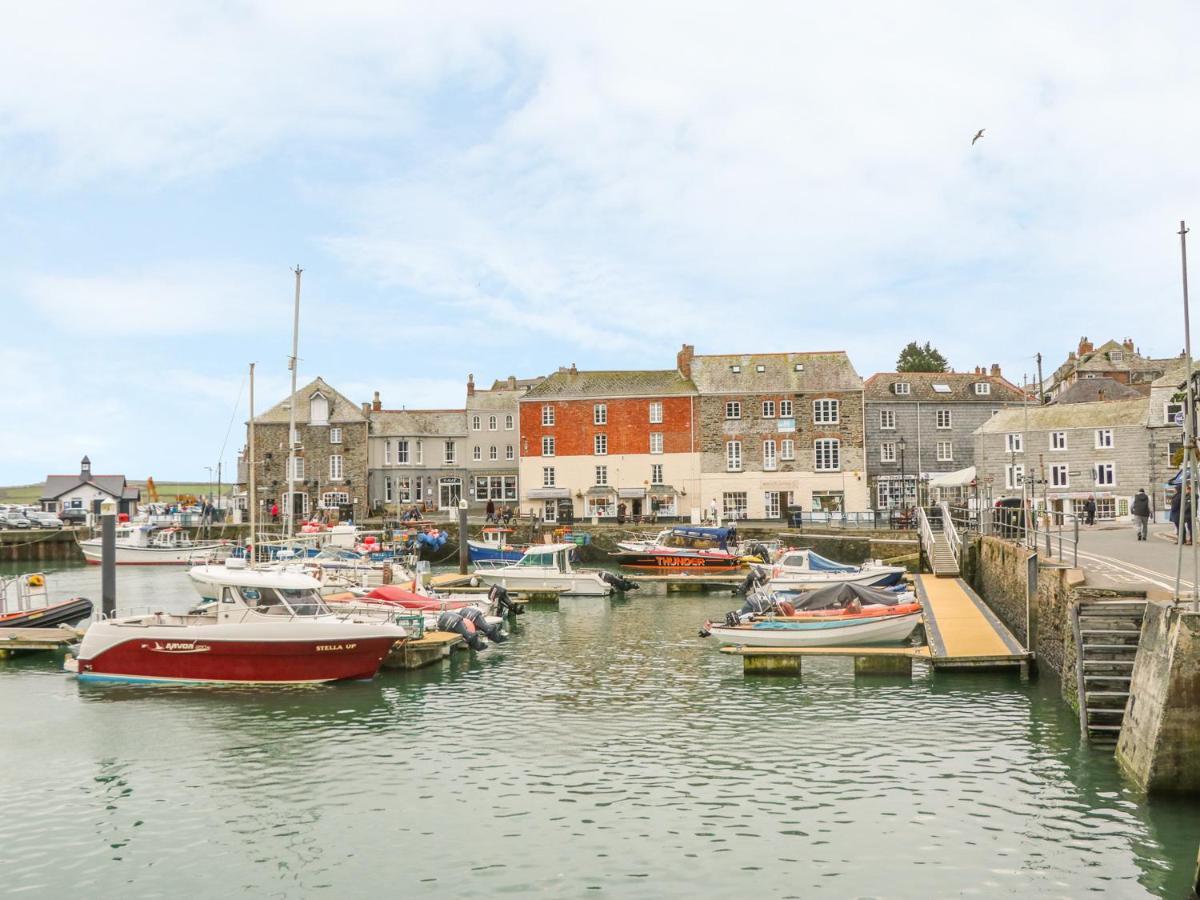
{"left": 1072, "top": 600, "right": 1146, "bottom": 744}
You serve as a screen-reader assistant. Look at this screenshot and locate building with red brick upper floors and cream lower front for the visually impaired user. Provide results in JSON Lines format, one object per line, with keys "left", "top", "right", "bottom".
{"left": 518, "top": 366, "right": 700, "bottom": 521}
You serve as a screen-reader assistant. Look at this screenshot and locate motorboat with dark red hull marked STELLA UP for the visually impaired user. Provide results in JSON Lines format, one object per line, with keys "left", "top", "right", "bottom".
{"left": 67, "top": 559, "right": 408, "bottom": 684}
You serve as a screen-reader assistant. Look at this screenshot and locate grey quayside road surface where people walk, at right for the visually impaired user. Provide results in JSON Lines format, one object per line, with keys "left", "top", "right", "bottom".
{"left": 1043, "top": 524, "right": 1200, "bottom": 592}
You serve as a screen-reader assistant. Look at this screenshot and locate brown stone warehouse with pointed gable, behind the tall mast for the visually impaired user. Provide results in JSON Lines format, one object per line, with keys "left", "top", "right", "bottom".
{"left": 247, "top": 378, "right": 367, "bottom": 522}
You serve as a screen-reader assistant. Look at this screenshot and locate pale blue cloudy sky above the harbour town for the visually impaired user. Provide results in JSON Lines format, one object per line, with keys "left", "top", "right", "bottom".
{"left": 0, "top": 0, "right": 1200, "bottom": 484}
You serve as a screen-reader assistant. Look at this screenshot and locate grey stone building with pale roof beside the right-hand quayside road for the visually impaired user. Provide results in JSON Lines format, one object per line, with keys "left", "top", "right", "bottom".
{"left": 974, "top": 397, "right": 1152, "bottom": 518}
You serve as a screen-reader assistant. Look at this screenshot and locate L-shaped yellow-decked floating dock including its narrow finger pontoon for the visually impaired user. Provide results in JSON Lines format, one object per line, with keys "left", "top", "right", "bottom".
{"left": 721, "top": 575, "right": 1032, "bottom": 677}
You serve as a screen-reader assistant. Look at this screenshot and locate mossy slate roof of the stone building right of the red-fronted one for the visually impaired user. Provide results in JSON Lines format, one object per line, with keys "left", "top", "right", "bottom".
{"left": 691, "top": 350, "right": 863, "bottom": 394}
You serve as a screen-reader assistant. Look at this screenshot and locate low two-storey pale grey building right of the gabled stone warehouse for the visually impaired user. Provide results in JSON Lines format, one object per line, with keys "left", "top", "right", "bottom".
{"left": 364, "top": 391, "right": 468, "bottom": 512}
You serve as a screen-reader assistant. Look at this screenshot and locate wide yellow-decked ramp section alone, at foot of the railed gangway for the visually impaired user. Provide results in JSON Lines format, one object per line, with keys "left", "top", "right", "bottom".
{"left": 916, "top": 575, "right": 1031, "bottom": 668}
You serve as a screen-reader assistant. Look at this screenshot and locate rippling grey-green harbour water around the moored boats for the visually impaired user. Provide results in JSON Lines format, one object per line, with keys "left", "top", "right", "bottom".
{"left": 0, "top": 568, "right": 1200, "bottom": 898}
